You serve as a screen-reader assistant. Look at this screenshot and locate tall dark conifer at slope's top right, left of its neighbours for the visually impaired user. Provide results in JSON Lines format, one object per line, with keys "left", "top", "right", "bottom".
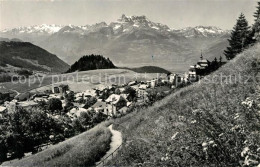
{"left": 224, "top": 13, "right": 250, "bottom": 60}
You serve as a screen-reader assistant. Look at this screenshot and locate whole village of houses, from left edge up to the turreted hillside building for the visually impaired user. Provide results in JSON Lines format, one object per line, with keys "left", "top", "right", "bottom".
{"left": 0, "top": 52, "right": 214, "bottom": 119}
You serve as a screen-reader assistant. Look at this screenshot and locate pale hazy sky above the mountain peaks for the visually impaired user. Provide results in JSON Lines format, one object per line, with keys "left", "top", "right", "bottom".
{"left": 0, "top": 0, "right": 257, "bottom": 29}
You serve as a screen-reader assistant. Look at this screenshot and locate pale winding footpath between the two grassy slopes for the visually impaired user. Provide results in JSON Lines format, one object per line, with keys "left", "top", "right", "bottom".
{"left": 96, "top": 125, "right": 123, "bottom": 167}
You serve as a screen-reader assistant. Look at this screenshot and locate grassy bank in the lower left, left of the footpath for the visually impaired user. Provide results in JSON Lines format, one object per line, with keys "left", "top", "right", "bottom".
{"left": 3, "top": 124, "right": 112, "bottom": 167}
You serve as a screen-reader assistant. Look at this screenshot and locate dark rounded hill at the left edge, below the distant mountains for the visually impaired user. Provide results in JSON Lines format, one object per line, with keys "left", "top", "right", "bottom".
{"left": 0, "top": 41, "right": 69, "bottom": 73}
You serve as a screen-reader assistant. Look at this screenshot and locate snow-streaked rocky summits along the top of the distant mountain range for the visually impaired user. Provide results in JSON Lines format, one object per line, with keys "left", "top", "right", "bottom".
{"left": 0, "top": 14, "right": 228, "bottom": 38}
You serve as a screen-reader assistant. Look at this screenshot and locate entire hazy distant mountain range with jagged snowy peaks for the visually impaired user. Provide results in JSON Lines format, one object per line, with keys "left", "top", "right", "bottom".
{"left": 0, "top": 15, "right": 230, "bottom": 71}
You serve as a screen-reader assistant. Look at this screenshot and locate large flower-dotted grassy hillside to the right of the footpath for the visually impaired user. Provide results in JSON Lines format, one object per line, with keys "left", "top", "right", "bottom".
{"left": 106, "top": 44, "right": 260, "bottom": 166}
